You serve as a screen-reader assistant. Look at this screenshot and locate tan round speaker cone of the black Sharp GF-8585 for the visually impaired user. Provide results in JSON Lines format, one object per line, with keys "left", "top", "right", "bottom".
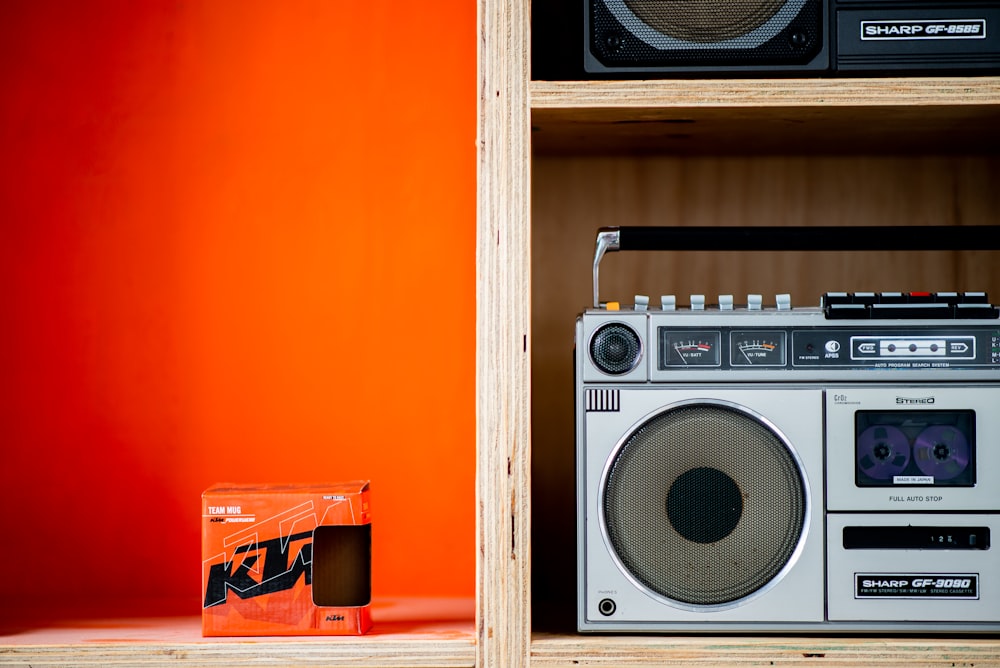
{"left": 624, "top": 0, "right": 788, "bottom": 43}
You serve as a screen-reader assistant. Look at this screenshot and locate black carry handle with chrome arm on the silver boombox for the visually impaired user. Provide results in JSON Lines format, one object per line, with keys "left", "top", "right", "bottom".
{"left": 594, "top": 225, "right": 1000, "bottom": 308}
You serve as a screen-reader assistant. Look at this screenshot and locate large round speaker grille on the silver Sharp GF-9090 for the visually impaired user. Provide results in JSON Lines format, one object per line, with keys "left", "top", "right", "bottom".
{"left": 603, "top": 403, "right": 806, "bottom": 606}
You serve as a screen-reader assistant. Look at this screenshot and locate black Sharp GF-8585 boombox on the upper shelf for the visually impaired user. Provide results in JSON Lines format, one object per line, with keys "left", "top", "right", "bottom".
{"left": 584, "top": 0, "right": 1000, "bottom": 77}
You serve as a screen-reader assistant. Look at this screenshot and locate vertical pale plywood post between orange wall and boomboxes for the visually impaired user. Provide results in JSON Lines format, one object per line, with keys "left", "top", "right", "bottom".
{"left": 476, "top": 0, "right": 531, "bottom": 668}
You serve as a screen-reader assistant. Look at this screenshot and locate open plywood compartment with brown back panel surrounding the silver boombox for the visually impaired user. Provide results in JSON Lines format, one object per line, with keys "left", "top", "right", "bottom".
{"left": 528, "top": 77, "right": 1000, "bottom": 667}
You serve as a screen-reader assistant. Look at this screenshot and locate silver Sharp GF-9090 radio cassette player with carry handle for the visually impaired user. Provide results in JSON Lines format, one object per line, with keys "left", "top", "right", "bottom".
{"left": 575, "top": 227, "right": 1000, "bottom": 633}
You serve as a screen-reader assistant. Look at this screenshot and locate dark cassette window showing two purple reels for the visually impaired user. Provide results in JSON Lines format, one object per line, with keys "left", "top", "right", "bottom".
{"left": 855, "top": 410, "right": 976, "bottom": 487}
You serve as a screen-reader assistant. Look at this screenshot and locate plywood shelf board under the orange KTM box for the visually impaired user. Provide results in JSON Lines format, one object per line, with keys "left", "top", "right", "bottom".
{"left": 0, "top": 599, "right": 476, "bottom": 668}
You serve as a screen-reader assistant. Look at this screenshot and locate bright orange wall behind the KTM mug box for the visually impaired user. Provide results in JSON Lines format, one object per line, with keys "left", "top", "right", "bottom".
{"left": 0, "top": 0, "right": 476, "bottom": 612}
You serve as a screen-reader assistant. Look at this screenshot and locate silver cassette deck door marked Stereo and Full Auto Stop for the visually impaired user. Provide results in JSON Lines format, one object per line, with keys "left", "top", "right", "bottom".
{"left": 826, "top": 384, "right": 1000, "bottom": 512}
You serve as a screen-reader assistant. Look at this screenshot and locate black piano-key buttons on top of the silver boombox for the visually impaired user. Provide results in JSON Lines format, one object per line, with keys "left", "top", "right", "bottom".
{"left": 820, "top": 292, "right": 1000, "bottom": 320}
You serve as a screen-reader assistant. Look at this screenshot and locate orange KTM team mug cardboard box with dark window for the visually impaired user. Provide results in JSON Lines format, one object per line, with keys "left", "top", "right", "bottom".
{"left": 202, "top": 480, "right": 371, "bottom": 636}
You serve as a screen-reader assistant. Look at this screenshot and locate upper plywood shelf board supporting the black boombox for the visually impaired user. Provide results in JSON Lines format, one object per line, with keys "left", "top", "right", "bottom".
{"left": 529, "top": 77, "right": 1000, "bottom": 156}
